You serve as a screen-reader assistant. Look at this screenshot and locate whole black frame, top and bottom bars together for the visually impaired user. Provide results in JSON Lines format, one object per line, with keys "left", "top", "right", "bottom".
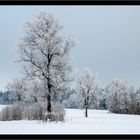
{"left": 0, "top": 0, "right": 140, "bottom": 140}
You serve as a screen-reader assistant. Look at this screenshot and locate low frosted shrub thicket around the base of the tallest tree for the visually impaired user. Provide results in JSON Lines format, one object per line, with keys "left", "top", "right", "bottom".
{"left": 0, "top": 102, "right": 65, "bottom": 122}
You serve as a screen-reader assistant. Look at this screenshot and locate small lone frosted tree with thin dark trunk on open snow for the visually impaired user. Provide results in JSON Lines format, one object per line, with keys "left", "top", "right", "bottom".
{"left": 76, "top": 69, "right": 98, "bottom": 117}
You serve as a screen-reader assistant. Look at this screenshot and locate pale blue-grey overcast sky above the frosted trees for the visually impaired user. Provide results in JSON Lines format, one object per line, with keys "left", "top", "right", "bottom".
{"left": 0, "top": 5, "right": 140, "bottom": 89}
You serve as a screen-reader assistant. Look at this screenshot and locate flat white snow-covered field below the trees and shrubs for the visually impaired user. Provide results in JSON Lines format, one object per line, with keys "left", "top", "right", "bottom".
{"left": 0, "top": 106, "right": 140, "bottom": 134}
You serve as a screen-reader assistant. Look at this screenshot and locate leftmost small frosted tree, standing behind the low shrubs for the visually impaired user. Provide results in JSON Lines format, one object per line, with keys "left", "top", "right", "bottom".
{"left": 6, "top": 78, "right": 27, "bottom": 102}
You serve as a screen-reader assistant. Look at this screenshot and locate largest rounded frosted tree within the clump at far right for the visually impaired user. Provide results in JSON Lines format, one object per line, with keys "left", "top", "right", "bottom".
{"left": 106, "top": 80, "right": 130, "bottom": 113}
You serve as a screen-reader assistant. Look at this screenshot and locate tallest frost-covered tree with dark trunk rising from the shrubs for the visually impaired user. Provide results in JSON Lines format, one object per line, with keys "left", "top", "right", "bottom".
{"left": 18, "top": 12, "right": 75, "bottom": 119}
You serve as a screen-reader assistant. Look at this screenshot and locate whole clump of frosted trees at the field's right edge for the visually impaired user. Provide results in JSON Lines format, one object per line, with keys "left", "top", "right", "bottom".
{"left": 106, "top": 80, "right": 140, "bottom": 114}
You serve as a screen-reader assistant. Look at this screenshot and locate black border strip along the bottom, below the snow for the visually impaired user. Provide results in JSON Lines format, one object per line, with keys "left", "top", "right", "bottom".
{"left": 0, "top": 134, "right": 140, "bottom": 140}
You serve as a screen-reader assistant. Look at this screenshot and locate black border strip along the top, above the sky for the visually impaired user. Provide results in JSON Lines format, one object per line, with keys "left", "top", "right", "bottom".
{"left": 0, "top": 0, "right": 140, "bottom": 6}
